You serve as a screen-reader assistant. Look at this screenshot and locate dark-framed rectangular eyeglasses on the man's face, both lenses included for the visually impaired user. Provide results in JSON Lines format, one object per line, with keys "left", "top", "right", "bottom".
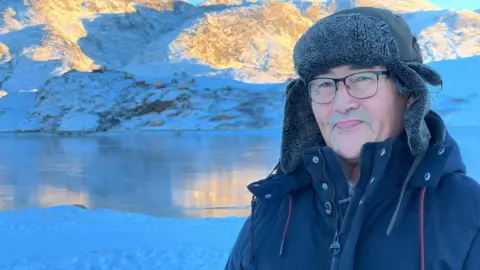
{"left": 308, "top": 71, "right": 390, "bottom": 104}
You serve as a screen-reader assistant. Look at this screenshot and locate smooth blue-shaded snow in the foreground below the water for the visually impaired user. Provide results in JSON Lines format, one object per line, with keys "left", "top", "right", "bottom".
{"left": 0, "top": 206, "right": 244, "bottom": 270}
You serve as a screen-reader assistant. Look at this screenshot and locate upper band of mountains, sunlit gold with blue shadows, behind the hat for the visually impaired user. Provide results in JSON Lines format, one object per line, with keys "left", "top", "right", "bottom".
{"left": 0, "top": 0, "right": 480, "bottom": 84}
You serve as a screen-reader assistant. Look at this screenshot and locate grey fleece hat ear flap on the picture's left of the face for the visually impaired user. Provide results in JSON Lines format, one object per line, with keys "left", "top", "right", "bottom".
{"left": 280, "top": 78, "right": 325, "bottom": 173}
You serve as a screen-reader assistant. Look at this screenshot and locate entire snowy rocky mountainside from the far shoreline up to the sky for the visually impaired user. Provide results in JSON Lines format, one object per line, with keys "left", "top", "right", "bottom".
{"left": 0, "top": 0, "right": 480, "bottom": 131}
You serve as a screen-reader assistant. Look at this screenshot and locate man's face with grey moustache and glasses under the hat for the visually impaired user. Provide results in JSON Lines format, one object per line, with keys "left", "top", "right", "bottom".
{"left": 309, "top": 66, "right": 408, "bottom": 159}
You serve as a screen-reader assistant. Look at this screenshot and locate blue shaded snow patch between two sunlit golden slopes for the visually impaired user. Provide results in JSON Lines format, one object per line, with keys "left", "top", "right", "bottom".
{"left": 79, "top": 2, "right": 213, "bottom": 76}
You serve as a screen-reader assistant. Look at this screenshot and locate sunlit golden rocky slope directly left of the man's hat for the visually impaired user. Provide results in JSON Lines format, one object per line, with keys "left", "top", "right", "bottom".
{"left": 171, "top": 2, "right": 312, "bottom": 81}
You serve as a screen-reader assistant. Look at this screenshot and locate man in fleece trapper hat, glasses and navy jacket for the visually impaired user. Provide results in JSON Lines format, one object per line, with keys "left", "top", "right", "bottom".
{"left": 225, "top": 5, "right": 480, "bottom": 270}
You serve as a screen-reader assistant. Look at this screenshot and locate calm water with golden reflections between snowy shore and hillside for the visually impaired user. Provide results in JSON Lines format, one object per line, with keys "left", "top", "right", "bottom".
{"left": 0, "top": 132, "right": 280, "bottom": 217}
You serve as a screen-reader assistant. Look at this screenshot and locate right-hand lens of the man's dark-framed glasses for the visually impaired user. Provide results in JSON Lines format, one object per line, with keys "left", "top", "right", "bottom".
{"left": 345, "top": 72, "right": 378, "bottom": 98}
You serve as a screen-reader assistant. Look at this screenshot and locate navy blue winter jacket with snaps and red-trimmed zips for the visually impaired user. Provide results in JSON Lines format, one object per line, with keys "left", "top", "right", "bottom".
{"left": 225, "top": 114, "right": 480, "bottom": 270}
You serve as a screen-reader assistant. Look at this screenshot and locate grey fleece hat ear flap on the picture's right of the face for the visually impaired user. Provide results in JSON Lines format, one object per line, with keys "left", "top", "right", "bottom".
{"left": 390, "top": 62, "right": 442, "bottom": 156}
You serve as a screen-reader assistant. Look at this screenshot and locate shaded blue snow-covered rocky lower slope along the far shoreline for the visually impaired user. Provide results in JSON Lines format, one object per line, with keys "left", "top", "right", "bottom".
{"left": 0, "top": 71, "right": 284, "bottom": 132}
